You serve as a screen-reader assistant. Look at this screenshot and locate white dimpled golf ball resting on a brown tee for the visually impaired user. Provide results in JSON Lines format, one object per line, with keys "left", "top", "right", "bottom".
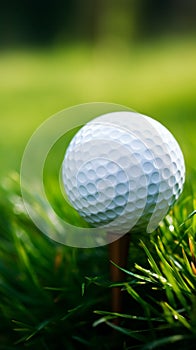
{"left": 62, "top": 111, "right": 185, "bottom": 233}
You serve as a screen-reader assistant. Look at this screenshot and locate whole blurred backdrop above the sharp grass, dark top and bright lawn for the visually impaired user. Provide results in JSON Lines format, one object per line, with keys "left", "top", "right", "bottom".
{"left": 0, "top": 0, "right": 196, "bottom": 177}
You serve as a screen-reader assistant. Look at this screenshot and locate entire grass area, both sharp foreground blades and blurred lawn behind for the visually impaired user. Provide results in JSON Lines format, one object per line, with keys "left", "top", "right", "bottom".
{"left": 0, "top": 38, "right": 196, "bottom": 350}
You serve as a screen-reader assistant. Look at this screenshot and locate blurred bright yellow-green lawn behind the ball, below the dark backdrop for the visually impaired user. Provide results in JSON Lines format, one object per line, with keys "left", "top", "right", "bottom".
{"left": 0, "top": 37, "right": 196, "bottom": 175}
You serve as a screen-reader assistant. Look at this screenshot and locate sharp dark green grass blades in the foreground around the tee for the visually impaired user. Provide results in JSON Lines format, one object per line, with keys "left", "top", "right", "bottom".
{"left": 0, "top": 174, "right": 196, "bottom": 350}
